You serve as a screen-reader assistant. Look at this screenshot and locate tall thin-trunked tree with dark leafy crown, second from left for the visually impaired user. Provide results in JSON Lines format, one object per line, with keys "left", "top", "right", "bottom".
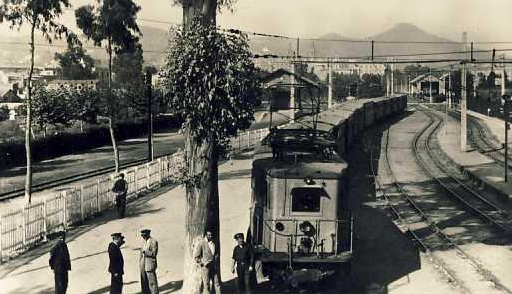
{"left": 75, "top": 0, "right": 140, "bottom": 172}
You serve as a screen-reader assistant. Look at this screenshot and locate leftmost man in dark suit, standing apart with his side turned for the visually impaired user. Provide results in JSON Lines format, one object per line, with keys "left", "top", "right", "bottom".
{"left": 48, "top": 231, "right": 71, "bottom": 294}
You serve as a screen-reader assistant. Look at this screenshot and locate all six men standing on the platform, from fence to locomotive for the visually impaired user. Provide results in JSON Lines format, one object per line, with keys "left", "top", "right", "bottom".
{"left": 49, "top": 174, "right": 254, "bottom": 294}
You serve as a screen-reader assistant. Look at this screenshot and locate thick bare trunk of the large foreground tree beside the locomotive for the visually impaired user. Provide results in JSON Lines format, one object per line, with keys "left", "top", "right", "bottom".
{"left": 182, "top": 0, "right": 220, "bottom": 294}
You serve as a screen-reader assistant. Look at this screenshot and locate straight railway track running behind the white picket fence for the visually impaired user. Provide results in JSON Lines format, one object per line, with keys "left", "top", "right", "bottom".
{"left": 0, "top": 154, "right": 169, "bottom": 201}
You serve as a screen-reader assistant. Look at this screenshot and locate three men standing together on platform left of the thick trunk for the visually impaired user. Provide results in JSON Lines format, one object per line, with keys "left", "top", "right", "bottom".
{"left": 49, "top": 229, "right": 158, "bottom": 294}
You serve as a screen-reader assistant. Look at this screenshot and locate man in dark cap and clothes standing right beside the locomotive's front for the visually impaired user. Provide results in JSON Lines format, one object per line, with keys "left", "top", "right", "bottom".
{"left": 231, "top": 233, "right": 254, "bottom": 293}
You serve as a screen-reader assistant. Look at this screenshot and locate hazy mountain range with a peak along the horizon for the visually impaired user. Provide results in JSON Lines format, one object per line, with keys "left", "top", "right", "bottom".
{"left": 0, "top": 23, "right": 490, "bottom": 66}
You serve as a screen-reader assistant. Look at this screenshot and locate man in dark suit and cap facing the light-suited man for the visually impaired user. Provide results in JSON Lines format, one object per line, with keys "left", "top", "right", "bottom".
{"left": 108, "top": 233, "right": 124, "bottom": 294}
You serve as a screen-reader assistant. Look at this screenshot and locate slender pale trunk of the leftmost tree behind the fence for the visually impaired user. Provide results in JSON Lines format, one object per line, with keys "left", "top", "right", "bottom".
{"left": 25, "top": 20, "right": 36, "bottom": 203}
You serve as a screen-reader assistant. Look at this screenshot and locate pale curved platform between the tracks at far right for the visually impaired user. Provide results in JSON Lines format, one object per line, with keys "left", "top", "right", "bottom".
{"left": 437, "top": 107, "right": 512, "bottom": 204}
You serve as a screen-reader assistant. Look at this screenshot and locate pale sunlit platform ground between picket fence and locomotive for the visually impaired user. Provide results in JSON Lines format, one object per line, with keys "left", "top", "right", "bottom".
{"left": 0, "top": 153, "right": 252, "bottom": 294}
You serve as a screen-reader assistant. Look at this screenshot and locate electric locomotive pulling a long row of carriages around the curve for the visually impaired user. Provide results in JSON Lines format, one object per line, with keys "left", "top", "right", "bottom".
{"left": 250, "top": 95, "right": 407, "bottom": 287}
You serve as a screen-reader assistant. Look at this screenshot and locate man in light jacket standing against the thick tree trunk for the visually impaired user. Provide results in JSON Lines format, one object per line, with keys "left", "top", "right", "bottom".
{"left": 194, "top": 231, "right": 221, "bottom": 294}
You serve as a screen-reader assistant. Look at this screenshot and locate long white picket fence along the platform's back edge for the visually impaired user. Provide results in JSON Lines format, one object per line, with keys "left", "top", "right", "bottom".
{"left": 0, "top": 129, "right": 268, "bottom": 262}
